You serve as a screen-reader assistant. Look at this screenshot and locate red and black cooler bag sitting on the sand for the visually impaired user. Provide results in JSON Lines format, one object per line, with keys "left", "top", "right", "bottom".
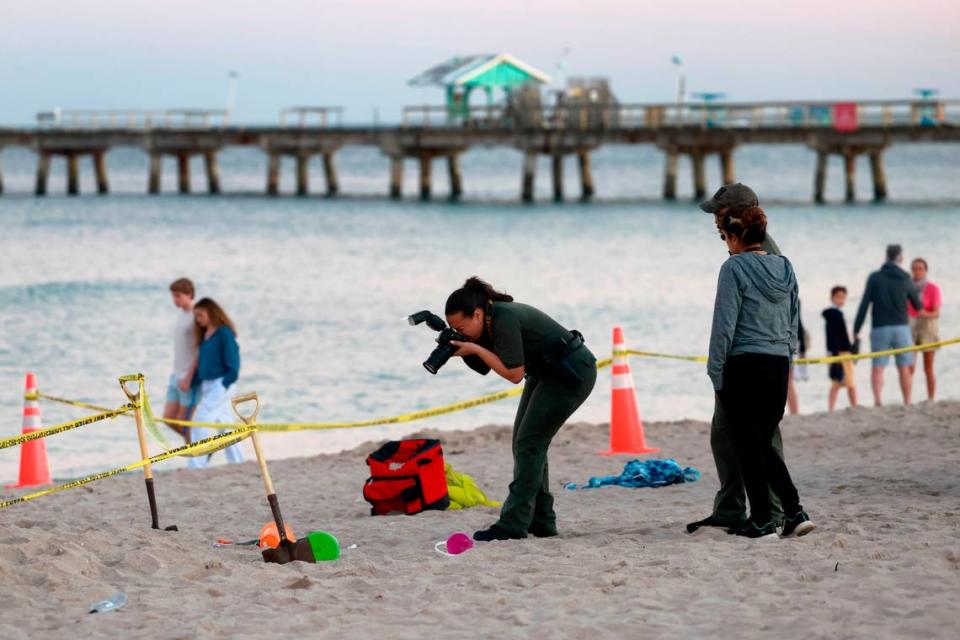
{"left": 363, "top": 440, "right": 450, "bottom": 516}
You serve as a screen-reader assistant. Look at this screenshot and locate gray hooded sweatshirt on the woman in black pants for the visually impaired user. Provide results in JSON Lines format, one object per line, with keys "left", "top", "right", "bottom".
{"left": 707, "top": 252, "right": 800, "bottom": 391}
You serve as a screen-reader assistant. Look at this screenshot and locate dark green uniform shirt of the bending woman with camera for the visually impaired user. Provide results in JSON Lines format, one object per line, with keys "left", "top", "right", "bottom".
{"left": 464, "top": 302, "right": 573, "bottom": 375}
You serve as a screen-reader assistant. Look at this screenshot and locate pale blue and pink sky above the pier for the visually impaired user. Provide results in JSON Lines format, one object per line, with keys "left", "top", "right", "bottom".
{"left": 0, "top": 0, "right": 960, "bottom": 126}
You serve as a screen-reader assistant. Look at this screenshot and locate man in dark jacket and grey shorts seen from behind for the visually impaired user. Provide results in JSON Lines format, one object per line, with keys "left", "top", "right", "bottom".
{"left": 853, "top": 244, "right": 923, "bottom": 407}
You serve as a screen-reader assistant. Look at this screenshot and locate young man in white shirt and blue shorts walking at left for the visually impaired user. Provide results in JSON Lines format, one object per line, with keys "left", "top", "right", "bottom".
{"left": 163, "top": 278, "right": 197, "bottom": 442}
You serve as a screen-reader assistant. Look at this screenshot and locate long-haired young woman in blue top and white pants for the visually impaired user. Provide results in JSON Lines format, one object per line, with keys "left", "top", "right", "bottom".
{"left": 187, "top": 298, "right": 243, "bottom": 468}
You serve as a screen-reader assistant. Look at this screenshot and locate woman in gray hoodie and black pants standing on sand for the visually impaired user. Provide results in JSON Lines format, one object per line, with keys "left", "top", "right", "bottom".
{"left": 707, "top": 207, "right": 814, "bottom": 538}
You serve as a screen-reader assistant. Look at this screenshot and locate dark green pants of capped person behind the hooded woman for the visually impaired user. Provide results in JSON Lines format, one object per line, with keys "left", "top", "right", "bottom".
{"left": 710, "top": 394, "right": 783, "bottom": 523}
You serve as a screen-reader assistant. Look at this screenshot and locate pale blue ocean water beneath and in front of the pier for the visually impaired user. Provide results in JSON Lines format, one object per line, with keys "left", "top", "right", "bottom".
{"left": 0, "top": 141, "right": 960, "bottom": 480}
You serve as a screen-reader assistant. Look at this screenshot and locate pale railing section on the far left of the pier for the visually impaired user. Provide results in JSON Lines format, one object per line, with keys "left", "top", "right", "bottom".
{"left": 37, "top": 109, "right": 230, "bottom": 129}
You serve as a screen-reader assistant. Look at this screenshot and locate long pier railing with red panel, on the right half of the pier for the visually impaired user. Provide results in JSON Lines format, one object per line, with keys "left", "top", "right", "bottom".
{"left": 402, "top": 100, "right": 960, "bottom": 131}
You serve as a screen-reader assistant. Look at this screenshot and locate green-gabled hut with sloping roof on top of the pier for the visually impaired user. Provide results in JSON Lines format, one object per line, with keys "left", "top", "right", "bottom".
{"left": 409, "top": 53, "right": 550, "bottom": 119}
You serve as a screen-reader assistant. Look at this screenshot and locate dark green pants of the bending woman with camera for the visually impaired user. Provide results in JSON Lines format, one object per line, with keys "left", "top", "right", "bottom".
{"left": 497, "top": 347, "right": 597, "bottom": 535}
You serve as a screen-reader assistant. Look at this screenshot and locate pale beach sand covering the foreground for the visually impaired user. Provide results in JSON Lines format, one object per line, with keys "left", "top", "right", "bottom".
{"left": 0, "top": 403, "right": 960, "bottom": 640}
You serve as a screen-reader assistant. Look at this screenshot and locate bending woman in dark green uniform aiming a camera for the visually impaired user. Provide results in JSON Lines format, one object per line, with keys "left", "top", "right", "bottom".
{"left": 445, "top": 277, "right": 597, "bottom": 541}
